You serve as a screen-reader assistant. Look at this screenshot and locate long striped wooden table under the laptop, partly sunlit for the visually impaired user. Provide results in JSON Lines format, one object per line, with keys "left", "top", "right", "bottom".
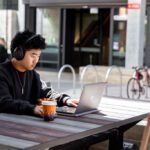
{"left": 0, "top": 97, "right": 150, "bottom": 150}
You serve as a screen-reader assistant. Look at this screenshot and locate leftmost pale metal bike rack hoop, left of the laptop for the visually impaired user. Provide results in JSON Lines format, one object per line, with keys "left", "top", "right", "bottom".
{"left": 58, "top": 64, "right": 76, "bottom": 93}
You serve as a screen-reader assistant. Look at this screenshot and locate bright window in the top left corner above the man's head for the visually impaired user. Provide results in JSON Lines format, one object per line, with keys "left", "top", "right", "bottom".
{"left": 0, "top": 0, "right": 24, "bottom": 53}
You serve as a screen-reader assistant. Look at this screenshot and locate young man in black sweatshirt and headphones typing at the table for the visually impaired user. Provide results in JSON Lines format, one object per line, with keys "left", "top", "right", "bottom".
{"left": 0, "top": 31, "right": 77, "bottom": 116}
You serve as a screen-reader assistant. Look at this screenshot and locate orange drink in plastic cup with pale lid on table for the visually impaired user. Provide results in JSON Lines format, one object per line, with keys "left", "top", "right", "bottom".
{"left": 42, "top": 101, "right": 56, "bottom": 121}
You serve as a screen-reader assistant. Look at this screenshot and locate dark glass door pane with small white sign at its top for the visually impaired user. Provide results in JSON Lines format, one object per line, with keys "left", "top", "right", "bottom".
{"left": 74, "top": 9, "right": 101, "bottom": 65}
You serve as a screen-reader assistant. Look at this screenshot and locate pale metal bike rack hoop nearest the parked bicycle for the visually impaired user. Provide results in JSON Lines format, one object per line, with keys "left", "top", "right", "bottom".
{"left": 105, "top": 66, "right": 122, "bottom": 97}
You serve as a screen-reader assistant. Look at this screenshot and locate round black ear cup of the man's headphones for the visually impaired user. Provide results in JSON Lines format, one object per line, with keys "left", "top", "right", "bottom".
{"left": 13, "top": 47, "right": 24, "bottom": 60}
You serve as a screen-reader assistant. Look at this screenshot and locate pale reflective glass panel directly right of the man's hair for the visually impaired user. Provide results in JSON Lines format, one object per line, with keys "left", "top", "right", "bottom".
{"left": 38, "top": 8, "right": 60, "bottom": 68}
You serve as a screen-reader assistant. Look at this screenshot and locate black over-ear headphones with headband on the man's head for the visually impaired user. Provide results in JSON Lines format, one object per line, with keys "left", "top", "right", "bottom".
{"left": 12, "top": 34, "right": 39, "bottom": 60}
